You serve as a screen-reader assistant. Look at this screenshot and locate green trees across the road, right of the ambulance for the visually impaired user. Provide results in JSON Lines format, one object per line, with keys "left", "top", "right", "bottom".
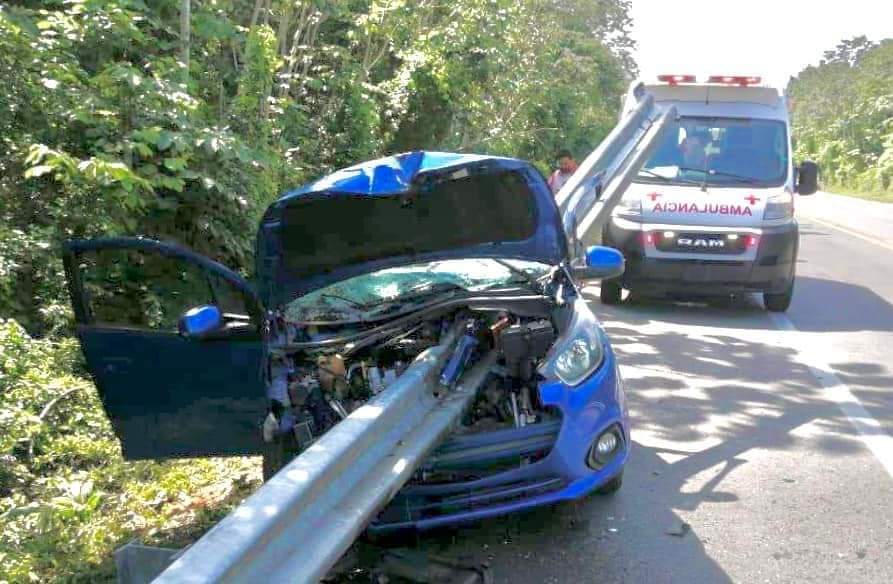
{"left": 788, "top": 37, "right": 893, "bottom": 201}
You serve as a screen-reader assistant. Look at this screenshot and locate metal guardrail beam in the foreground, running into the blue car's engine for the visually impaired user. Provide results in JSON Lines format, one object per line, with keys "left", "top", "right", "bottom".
{"left": 154, "top": 328, "right": 495, "bottom": 584}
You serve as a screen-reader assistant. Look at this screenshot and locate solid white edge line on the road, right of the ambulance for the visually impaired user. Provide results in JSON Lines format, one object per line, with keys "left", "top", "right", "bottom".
{"left": 769, "top": 313, "right": 893, "bottom": 478}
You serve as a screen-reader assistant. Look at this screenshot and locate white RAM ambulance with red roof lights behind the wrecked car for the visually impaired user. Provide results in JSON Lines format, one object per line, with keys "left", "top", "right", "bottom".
{"left": 601, "top": 74, "right": 818, "bottom": 312}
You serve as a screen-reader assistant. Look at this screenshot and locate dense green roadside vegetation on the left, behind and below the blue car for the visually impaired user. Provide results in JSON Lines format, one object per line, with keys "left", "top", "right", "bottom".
{"left": 0, "top": 0, "right": 634, "bottom": 582}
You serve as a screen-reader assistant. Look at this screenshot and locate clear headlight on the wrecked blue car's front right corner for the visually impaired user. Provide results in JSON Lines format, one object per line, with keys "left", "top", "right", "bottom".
{"left": 545, "top": 299, "right": 605, "bottom": 386}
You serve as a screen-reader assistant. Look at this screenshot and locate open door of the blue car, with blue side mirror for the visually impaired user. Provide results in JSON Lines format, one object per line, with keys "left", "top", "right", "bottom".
{"left": 64, "top": 238, "right": 267, "bottom": 459}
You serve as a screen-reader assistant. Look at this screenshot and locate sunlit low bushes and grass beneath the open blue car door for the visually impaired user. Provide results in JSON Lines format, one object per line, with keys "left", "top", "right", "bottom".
{"left": 0, "top": 320, "right": 260, "bottom": 582}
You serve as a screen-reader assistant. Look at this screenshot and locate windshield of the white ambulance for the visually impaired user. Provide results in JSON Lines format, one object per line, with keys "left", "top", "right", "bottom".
{"left": 636, "top": 117, "right": 788, "bottom": 187}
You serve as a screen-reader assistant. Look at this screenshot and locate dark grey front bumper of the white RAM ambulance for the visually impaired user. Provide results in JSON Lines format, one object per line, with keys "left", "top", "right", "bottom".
{"left": 603, "top": 221, "right": 799, "bottom": 296}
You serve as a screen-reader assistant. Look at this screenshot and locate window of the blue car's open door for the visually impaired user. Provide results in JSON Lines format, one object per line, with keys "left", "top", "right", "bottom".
{"left": 78, "top": 249, "right": 247, "bottom": 332}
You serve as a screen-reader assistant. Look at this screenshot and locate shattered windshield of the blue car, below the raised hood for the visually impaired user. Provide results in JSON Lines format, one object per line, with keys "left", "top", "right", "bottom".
{"left": 284, "top": 258, "right": 551, "bottom": 322}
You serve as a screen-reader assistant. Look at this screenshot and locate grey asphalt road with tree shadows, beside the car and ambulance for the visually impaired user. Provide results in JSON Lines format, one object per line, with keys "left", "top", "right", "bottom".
{"left": 402, "top": 196, "right": 893, "bottom": 584}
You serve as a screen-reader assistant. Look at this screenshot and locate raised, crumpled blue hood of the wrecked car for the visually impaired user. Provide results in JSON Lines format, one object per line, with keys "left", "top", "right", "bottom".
{"left": 256, "top": 152, "right": 567, "bottom": 308}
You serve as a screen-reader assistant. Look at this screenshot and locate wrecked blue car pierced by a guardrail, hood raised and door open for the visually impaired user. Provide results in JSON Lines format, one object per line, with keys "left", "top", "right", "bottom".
{"left": 64, "top": 152, "right": 630, "bottom": 531}
